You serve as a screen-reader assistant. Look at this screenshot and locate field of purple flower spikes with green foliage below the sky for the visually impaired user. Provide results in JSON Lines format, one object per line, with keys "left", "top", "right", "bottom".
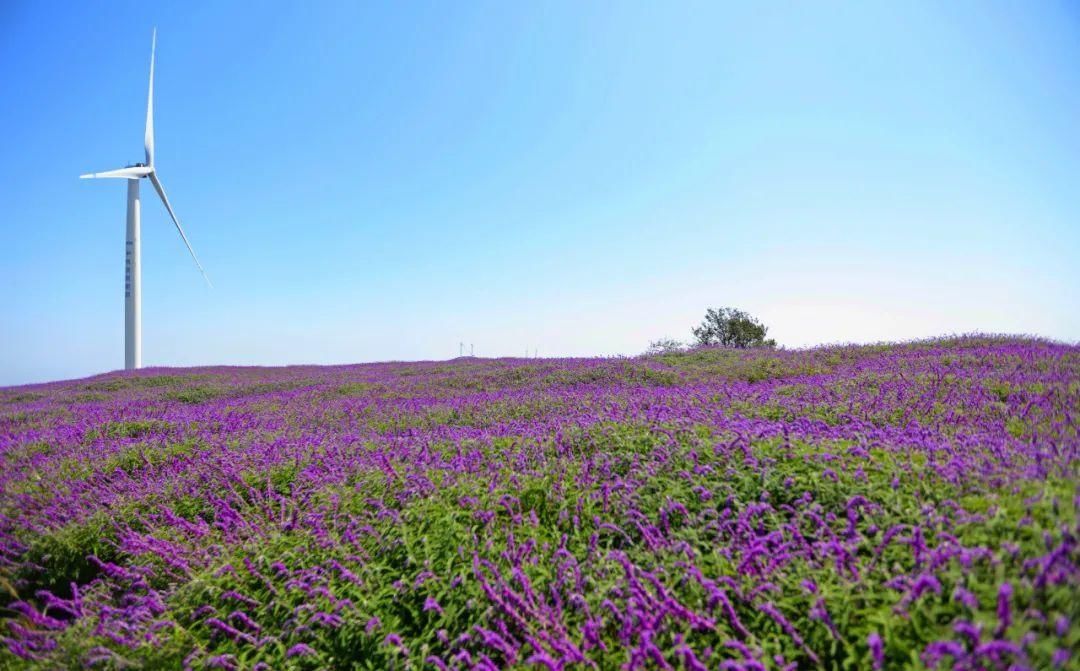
{"left": 0, "top": 336, "right": 1080, "bottom": 671}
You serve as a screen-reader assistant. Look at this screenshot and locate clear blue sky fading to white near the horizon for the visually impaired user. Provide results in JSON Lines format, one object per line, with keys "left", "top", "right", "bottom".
{"left": 0, "top": 1, "right": 1080, "bottom": 385}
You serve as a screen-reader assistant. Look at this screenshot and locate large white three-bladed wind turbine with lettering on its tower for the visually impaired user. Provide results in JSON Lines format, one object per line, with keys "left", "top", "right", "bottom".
{"left": 80, "top": 28, "right": 213, "bottom": 371}
